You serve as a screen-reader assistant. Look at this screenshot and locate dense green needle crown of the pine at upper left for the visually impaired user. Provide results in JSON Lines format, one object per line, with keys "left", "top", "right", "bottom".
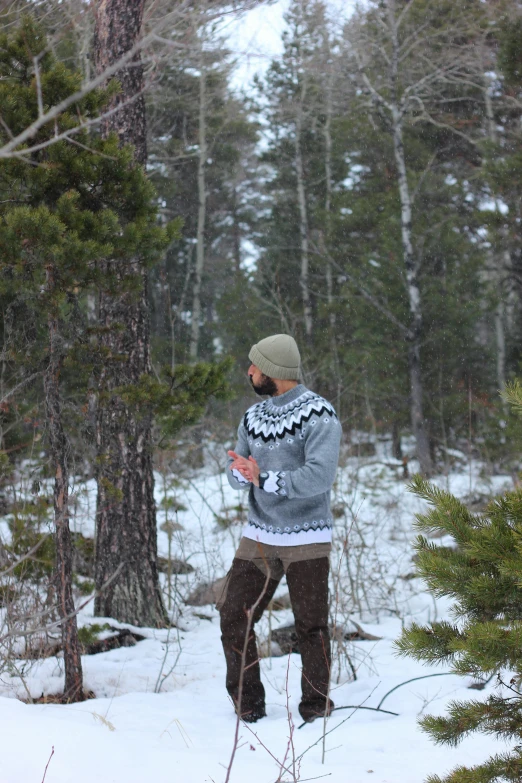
{"left": 0, "top": 17, "right": 175, "bottom": 292}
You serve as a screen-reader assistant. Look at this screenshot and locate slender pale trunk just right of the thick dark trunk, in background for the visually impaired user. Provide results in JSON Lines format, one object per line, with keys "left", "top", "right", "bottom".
{"left": 190, "top": 50, "right": 207, "bottom": 362}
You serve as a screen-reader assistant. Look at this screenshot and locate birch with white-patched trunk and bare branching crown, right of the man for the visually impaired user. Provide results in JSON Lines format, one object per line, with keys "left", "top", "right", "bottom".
{"left": 347, "top": 0, "right": 476, "bottom": 475}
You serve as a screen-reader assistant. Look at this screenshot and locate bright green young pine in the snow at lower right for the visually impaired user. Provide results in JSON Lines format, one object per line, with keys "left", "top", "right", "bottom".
{"left": 397, "top": 384, "right": 522, "bottom": 783}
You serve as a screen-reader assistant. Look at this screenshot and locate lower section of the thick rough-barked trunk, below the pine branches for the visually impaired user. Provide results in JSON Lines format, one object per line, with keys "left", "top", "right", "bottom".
{"left": 95, "top": 261, "right": 166, "bottom": 627}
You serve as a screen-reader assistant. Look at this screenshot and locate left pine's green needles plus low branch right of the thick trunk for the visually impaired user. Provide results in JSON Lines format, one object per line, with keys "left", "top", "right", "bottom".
{"left": 0, "top": 18, "right": 230, "bottom": 474}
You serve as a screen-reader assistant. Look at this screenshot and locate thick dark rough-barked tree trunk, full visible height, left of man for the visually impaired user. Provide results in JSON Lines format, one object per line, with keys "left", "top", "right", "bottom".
{"left": 94, "top": 0, "right": 166, "bottom": 627}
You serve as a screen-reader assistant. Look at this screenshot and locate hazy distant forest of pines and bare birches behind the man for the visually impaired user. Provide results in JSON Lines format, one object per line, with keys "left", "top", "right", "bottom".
{"left": 1, "top": 0, "right": 521, "bottom": 480}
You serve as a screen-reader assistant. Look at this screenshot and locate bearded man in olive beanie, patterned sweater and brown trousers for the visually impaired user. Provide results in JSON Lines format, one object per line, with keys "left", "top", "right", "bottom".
{"left": 218, "top": 334, "right": 341, "bottom": 723}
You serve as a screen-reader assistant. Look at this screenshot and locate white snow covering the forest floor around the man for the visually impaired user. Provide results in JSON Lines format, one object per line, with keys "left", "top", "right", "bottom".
{"left": 0, "top": 444, "right": 513, "bottom": 783}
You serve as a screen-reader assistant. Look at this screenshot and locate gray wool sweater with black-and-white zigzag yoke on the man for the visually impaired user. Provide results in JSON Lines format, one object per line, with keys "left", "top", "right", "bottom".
{"left": 227, "top": 384, "right": 341, "bottom": 546}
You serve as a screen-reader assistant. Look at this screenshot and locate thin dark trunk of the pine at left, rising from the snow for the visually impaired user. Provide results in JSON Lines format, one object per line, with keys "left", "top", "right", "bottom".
{"left": 44, "top": 266, "right": 85, "bottom": 702}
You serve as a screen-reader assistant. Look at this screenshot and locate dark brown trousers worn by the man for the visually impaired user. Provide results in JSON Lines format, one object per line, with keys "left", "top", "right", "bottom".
{"left": 218, "top": 557, "right": 333, "bottom": 720}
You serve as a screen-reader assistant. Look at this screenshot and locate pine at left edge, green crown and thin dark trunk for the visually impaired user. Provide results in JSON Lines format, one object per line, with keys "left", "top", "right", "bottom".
{"left": 0, "top": 17, "right": 169, "bottom": 701}
